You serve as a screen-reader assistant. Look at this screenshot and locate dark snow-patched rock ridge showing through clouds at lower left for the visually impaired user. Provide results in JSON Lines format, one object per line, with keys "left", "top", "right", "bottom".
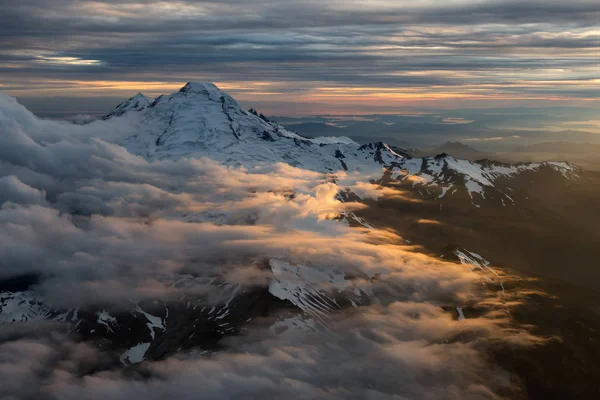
{"left": 0, "top": 287, "right": 299, "bottom": 365}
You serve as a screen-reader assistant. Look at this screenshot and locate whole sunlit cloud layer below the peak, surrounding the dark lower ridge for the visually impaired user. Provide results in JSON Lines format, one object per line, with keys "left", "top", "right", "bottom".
{"left": 0, "top": 96, "right": 539, "bottom": 399}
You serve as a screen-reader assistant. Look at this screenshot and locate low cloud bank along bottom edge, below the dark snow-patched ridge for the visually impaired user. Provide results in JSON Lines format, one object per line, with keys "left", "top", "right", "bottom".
{"left": 0, "top": 302, "right": 534, "bottom": 400}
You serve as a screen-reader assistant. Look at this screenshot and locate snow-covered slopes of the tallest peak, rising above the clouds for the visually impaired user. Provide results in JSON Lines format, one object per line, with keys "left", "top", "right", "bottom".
{"left": 105, "top": 83, "right": 403, "bottom": 174}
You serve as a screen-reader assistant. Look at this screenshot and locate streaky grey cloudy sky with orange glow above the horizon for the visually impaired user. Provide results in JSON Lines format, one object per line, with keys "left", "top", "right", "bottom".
{"left": 0, "top": 0, "right": 600, "bottom": 115}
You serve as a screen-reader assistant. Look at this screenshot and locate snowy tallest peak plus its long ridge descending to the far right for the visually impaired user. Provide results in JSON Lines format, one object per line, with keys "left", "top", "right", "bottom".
{"left": 107, "top": 83, "right": 580, "bottom": 207}
